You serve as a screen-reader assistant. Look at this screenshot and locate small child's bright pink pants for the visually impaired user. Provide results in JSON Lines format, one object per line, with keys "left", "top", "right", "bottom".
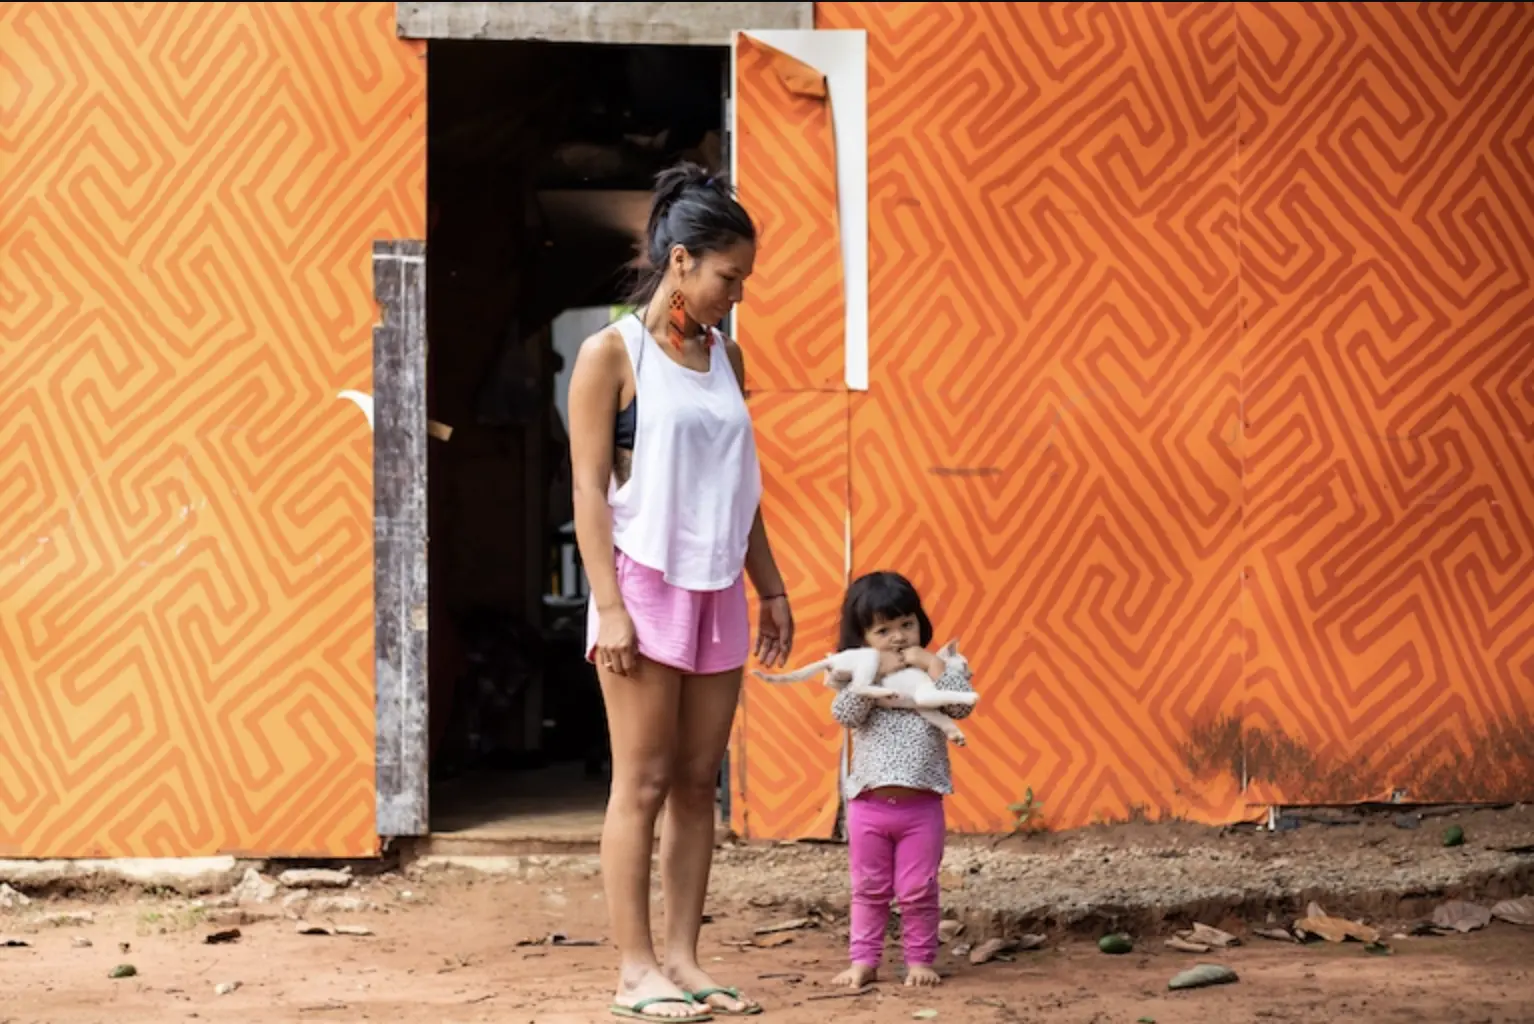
{"left": 847, "top": 793, "right": 946, "bottom": 967}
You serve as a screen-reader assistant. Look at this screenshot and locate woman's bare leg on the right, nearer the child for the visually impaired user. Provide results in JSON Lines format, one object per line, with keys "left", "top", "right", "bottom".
{"left": 661, "top": 668, "right": 749, "bottom": 1010}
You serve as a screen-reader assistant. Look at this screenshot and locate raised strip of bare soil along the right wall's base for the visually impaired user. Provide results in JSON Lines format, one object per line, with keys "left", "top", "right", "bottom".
{"left": 715, "top": 806, "right": 1534, "bottom": 938}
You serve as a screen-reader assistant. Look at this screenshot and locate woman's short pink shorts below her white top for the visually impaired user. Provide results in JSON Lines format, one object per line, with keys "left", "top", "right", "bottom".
{"left": 586, "top": 552, "right": 752, "bottom": 676}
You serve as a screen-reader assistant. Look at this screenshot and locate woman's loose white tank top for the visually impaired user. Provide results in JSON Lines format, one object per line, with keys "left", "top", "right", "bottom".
{"left": 607, "top": 316, "right": 762, "bottom": 590}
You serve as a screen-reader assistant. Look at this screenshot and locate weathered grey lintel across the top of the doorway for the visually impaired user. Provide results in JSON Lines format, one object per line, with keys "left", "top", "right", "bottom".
{"left": 394, "top": 3, "right": 815, "bottom": 46}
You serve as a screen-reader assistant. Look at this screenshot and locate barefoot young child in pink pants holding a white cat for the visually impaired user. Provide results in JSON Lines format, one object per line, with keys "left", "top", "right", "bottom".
{"left": 831, "top": 572, "right": 973, "bottom": 989}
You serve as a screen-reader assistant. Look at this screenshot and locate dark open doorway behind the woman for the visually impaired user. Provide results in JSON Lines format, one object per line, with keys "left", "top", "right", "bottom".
{"left": 426, "top": 40, "right": 729, "bottom": 843}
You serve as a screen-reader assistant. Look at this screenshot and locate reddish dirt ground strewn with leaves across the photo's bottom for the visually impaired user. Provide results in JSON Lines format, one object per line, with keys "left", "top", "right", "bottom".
{"left": 0, "top": 817, "right": 1534, "bottom": 1024}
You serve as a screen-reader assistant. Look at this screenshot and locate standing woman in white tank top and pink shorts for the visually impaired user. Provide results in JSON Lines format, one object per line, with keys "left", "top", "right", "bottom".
{"left": 569, "top": 164, "right": 793, "bottom": 1021}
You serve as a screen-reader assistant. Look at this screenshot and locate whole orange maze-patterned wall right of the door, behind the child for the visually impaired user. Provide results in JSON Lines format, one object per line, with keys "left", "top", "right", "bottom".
{"left": 779, "top": 3, "right": 1534, "bottom": 831}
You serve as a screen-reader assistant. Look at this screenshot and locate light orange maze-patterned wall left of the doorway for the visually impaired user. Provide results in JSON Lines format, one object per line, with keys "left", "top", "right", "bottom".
{"left": 0, "top": 3, "right": 425, "bottom": 857}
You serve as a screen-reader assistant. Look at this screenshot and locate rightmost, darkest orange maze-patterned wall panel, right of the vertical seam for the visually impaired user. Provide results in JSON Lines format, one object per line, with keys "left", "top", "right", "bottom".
{"left": 1239, "top": 3, "right": 1534, "bottom": 802}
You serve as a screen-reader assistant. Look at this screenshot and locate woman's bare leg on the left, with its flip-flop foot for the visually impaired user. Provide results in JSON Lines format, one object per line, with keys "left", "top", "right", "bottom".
{"left": 597, "top": 658, "right": 696, "bottom": 1019}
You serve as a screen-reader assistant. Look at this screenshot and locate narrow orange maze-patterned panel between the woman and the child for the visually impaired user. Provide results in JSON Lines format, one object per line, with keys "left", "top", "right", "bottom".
{"left": 729, "top": 34, "right": 850, "bottom": 837}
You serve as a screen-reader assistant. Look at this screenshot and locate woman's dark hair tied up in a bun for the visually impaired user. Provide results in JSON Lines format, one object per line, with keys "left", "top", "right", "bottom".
{"left": 629, "top": 161, "right": 756, "bottom": 305}
